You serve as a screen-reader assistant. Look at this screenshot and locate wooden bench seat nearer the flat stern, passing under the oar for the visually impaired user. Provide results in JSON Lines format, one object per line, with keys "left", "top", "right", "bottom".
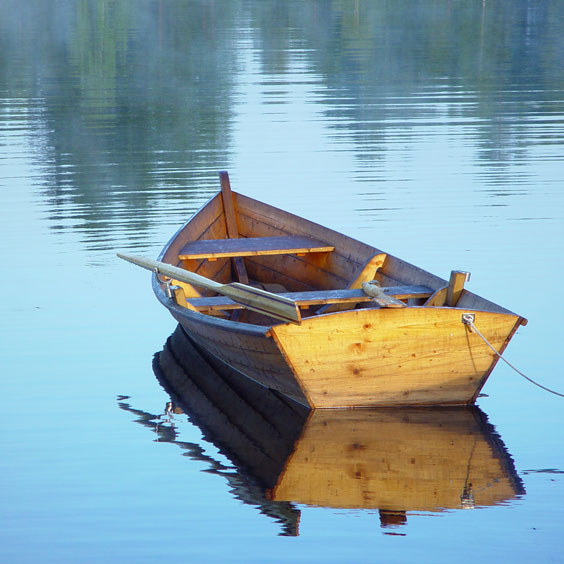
{"left": 187, "top": 286, "right": 433, "bottom": 312}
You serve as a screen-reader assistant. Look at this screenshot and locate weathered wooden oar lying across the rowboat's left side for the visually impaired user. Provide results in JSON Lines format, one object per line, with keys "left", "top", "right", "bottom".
{"left": 117, "top": 253, "right": 302, "bottom": 324}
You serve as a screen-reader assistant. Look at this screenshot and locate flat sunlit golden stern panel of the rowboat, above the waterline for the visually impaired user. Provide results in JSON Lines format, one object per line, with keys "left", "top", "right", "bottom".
{"left": 271, "top": 307, "right": 518, "bottom": 407}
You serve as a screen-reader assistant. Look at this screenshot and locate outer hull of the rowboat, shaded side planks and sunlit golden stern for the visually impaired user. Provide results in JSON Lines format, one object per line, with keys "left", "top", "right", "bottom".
{"left": 163, "top": 298, "right": 520, "bottom": 408}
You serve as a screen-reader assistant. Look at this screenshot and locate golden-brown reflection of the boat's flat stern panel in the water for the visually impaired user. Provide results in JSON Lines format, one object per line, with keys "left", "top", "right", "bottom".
{"left": 272, "top": 408, "right": 518, "bottom": 511}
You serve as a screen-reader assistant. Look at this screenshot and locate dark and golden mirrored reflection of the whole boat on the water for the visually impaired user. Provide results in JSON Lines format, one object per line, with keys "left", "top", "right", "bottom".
{"left": 121, "top": 327, "right": 524, "bottom": 535}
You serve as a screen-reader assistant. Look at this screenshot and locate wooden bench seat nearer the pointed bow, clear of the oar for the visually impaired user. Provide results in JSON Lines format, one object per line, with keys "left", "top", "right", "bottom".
{"left": 178, "top": 236, "right": 335, "bottom": 260}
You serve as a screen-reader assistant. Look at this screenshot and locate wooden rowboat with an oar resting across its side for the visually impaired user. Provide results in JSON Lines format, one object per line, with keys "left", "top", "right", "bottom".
{"left": 121, "top": 172, "right": 527, "bottom": 408}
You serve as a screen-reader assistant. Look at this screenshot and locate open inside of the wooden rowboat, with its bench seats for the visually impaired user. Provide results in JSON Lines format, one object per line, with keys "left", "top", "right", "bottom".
{"left": 156, "top": 172, "right": 511, "bottom": 325}
